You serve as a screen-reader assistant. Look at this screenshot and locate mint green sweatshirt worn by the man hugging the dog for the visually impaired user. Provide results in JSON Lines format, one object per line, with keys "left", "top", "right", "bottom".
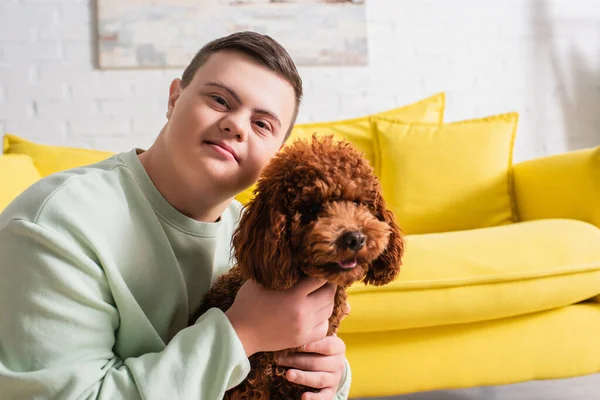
{"left": 0, "top": 150, "right": 351, "bottom": 400}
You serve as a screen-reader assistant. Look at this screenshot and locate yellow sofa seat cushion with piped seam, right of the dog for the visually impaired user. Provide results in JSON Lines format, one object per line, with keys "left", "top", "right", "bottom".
{"left": 340, "top": 219, "right": 600, "bottom": 332}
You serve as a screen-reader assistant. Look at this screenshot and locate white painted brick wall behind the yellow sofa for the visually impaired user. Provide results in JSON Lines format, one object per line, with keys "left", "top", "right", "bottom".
{"left": 0, "top": 0, "right": 600, "bottom": 160}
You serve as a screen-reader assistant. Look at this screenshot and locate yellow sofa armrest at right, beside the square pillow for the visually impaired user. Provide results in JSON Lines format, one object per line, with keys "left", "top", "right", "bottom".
{"left": 513, "top": 146, "right": 600, "bottom": 227}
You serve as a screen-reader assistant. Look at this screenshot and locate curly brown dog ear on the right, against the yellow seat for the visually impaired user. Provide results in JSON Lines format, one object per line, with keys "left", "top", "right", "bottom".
{"left": 363, "top": 193, "right": 404, "bottom": 286}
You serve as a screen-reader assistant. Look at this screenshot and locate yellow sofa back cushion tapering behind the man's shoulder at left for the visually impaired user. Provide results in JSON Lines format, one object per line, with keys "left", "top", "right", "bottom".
{"left": 4, "top": 134, "right": 113, "bottom": 176}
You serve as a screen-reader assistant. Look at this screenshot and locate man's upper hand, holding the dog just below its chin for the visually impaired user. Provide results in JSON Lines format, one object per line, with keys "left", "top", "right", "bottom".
{"left": 225, "top": 277, "right": 336, "bottom": 357}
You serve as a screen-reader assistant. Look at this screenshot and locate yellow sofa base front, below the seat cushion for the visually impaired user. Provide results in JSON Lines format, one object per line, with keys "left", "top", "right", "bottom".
{"left": 340, "top": 304, "right": 600, "bottom": 398}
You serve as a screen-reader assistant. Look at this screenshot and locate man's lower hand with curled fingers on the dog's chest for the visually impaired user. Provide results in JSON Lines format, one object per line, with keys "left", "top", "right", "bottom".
{"left": 277, "top": 335, "right": 346, "bottom": 400}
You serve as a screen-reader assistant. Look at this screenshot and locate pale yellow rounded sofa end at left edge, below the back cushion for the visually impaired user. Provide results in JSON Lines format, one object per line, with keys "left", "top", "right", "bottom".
{"left": 0, "top": 155, "right": 41, "bottom": 212}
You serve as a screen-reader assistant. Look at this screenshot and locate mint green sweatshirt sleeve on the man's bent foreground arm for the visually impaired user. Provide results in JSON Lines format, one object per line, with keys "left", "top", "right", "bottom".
{"left": 0, "top": 220, "right": 250, "bottom": 400}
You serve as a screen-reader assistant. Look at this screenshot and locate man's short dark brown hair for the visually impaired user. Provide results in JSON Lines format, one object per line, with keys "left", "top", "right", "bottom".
{"left": 181, "top": 31, "right": 302, "bottom": 143}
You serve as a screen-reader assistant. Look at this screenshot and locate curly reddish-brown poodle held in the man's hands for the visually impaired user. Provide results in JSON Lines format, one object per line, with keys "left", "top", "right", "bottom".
{"left": 190, "top": 136, "right": 404, "bottom": 400}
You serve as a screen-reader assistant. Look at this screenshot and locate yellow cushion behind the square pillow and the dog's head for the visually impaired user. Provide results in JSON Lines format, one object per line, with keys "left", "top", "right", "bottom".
{"left": 236, "top": 93, "right": 445, "bottom": 204}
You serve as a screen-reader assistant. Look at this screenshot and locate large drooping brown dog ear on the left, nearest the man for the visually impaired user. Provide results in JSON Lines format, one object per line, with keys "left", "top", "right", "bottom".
{"left": 232, "top": 193, "right": 299, "bottom": 290}
